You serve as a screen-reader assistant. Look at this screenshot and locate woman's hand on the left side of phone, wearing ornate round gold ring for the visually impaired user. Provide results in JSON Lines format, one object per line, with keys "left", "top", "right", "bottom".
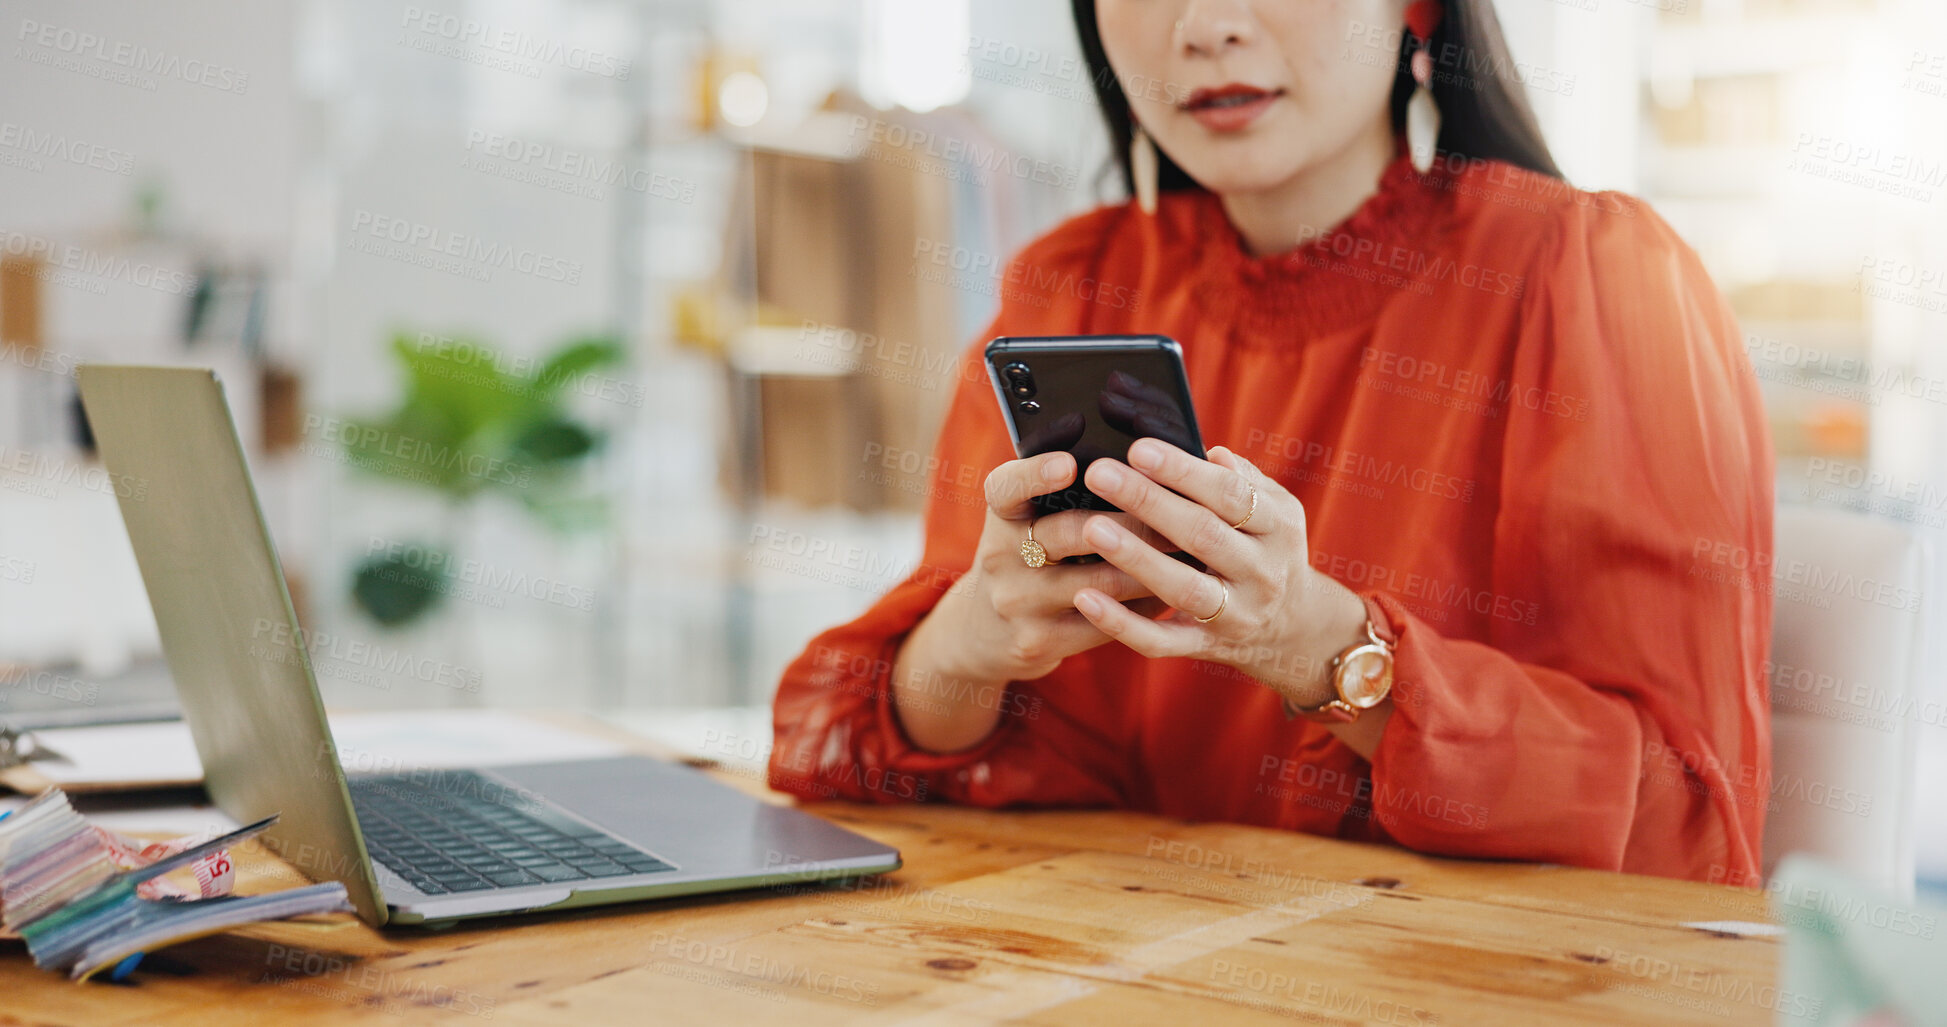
{"left": 894, "top": 452, "right": 1174, "bottom": 752}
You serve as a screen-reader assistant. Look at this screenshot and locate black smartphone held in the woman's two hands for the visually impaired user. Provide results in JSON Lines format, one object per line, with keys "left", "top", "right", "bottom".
{"left": 987, "top": 335, "right": 1203, "bottom": 514}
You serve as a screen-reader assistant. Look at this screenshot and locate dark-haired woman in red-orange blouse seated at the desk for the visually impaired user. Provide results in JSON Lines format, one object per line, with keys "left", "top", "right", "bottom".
{"left": 771, "top": 0, "right": 1772, "bottom": 881}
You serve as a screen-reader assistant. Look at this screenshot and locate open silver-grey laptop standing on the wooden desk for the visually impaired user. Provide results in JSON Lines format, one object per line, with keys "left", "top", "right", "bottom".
{"left": 78, "top": 364, "right": 900, "bottom": 926}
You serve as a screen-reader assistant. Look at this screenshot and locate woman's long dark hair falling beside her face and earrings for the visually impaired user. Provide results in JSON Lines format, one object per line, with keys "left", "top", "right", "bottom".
{"left": 1073, "top": 0, "right": 1561, "bottom": 195}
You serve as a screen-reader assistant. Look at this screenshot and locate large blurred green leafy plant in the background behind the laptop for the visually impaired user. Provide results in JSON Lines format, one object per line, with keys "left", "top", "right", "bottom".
{"left": 343, "top": 333, "right": 623, "bottom": 626}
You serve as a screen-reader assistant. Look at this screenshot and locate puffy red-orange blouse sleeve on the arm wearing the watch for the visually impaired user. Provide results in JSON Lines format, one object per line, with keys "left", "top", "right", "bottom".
{"left": 1373, "top": 197, "right": 1772, "bottom": 879}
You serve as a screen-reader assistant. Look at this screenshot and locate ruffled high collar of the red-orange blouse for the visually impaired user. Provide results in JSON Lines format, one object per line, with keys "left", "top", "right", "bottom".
{"left": 1194, "top": 152, "right": 1452, "bottom": 343}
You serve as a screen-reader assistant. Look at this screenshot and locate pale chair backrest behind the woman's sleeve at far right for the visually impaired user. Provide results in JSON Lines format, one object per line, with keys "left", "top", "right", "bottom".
{"left": 1764, "top": 507, "right": 1933, "bottom": 896}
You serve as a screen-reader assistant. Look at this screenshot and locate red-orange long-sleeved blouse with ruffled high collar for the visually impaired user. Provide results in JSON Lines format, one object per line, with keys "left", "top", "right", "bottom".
{"left": 771, "top": 152, "right": 1772, "bottom": 881}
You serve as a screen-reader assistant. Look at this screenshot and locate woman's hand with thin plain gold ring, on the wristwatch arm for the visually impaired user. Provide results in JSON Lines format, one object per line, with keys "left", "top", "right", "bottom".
{"left": 1075, "top": 438, "right": 1367, "bottom": 707}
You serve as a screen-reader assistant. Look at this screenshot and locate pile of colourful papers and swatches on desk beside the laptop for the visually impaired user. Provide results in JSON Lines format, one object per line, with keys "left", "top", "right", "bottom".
{"left": 0, "top": 789, "right": 352, "bottom": 978}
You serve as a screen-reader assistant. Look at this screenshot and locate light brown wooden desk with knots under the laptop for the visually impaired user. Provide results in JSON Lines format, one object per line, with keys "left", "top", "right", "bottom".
{"left": 0, "top": 724, "right": 1797, "bottom": 1027}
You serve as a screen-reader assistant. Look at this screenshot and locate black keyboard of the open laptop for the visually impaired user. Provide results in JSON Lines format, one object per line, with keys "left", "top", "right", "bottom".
{"left": 349, "top": 770, "right": 676, "bottom": 894}
